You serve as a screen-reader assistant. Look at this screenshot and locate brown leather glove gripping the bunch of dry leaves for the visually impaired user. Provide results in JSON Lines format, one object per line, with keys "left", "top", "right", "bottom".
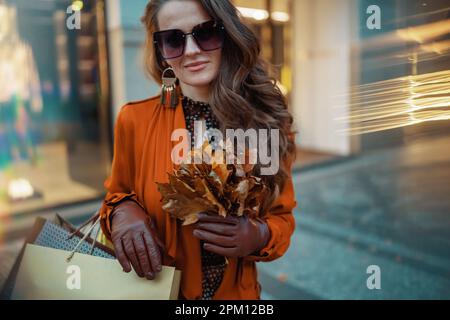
{"left": 194, "top": 213, "right": 270, "bottom": 257}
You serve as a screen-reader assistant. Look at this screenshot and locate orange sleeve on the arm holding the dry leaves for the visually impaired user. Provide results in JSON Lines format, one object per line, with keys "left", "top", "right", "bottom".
{"left": 245, "top": 154, "right": 297, "bottom": 262}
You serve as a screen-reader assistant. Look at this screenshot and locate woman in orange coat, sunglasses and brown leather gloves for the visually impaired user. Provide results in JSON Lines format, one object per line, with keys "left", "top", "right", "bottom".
{"left": 101, "top": 0, "right": 296, "bottom": 299}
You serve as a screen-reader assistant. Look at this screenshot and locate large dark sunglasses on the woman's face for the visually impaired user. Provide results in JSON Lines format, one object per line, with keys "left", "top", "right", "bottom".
{"left": 153, "top": 20, "right": 225, "bottom": 59}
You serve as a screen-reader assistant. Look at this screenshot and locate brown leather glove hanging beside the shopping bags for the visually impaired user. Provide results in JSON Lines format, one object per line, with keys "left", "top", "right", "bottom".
{"left": 110, "top": 200, "right": 164, "bottom": 280}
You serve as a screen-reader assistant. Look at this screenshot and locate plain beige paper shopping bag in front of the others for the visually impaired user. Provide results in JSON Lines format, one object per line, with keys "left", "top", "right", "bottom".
{"left": 12, "top": 244, "right": 181, "bottom": 300}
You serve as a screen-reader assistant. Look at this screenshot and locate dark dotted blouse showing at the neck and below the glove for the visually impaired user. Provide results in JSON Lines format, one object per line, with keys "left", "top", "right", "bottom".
{"left": 182, "top": 96, "right": 226, "bottom": 300}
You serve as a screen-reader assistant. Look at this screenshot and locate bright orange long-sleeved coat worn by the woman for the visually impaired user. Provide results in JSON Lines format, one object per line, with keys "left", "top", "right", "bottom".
{"left": 100, "top": 96, "right": 296, "bottom": 299}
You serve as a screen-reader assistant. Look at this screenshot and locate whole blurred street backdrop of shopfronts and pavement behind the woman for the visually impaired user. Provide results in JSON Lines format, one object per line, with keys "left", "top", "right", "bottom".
{"left": 0, "top": 0, "right": 450, "bottom": 299}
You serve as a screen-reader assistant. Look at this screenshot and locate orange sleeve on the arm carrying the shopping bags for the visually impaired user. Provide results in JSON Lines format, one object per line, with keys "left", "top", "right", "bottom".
{"left": 100, "top": 106, "right": 144, "bottom": 240}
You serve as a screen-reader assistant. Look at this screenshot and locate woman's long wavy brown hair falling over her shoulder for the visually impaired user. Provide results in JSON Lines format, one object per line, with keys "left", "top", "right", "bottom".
{"left": 142, "top": 0, "right": 295, "bottom": 214}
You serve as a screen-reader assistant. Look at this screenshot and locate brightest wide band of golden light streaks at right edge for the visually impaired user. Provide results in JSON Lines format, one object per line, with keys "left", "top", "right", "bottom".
{"left": 337, "top": 70, "right": 450, "bottom": 135}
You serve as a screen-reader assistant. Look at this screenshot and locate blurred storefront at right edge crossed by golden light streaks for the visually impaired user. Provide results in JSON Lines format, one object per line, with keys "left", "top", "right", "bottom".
{"left": 351, "top": 0, "right": 450, "bottom": 152}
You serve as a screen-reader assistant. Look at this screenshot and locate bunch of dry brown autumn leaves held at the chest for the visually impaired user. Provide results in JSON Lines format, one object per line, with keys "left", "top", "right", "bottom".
{"left": 158, "top": 142, "right": 269, "bottom": 225}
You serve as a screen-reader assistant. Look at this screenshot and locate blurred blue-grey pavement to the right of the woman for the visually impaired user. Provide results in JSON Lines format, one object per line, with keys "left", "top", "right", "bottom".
{"left": 258, "top": 137, "right": 450, "bottom": 299}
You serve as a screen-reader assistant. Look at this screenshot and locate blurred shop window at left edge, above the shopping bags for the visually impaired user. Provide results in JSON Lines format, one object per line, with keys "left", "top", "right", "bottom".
{"left": 0, "top": 0, "right": 111, "bottom": 217}
